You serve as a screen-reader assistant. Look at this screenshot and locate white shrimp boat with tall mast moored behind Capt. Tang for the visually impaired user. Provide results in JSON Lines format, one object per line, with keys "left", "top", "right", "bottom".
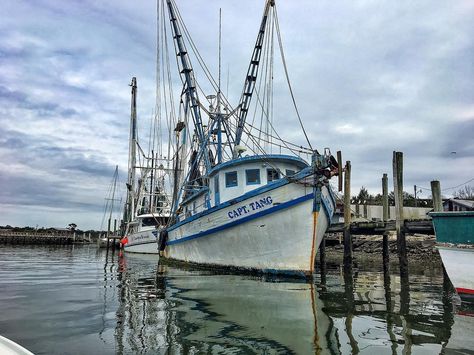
{"left": 120, "top": 77, "right": 170, "bottom": 254}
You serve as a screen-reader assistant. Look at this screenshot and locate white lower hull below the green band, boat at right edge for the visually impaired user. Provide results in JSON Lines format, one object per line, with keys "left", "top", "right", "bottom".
{"left": 438, "top": 246, "right": 474, "bottom": 299}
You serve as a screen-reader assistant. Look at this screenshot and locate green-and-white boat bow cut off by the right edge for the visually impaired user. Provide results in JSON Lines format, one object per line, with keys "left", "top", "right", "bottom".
{"left": 430, "top": 211, "right": 474, "bottom": 302}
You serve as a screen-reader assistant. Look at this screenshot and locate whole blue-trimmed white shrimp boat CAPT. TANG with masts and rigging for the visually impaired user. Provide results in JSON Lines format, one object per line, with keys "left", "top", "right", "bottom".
{"left": 159, "top": 0, "right": 341, "bottom": 275}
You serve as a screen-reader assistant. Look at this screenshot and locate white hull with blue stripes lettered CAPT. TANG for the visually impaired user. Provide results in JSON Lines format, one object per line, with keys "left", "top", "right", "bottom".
{"left": 164, "top": 183, "right": 334, "bottom": 274}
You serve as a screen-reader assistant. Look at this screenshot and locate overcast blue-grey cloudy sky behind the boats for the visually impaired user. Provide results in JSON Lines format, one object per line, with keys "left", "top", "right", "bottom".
{"left": 0, "top": 0, "right": 474, "bottom": 229}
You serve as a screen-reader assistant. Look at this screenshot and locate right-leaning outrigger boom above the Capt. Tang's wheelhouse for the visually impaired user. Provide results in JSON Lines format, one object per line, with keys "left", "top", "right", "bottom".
{"left": 232, "top": 0, "right": 275, "bottom": 158}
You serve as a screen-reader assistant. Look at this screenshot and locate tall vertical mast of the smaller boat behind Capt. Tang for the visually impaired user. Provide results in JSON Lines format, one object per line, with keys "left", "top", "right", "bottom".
{"left": 127, "top": 77, "right": 137, "bottom": 222}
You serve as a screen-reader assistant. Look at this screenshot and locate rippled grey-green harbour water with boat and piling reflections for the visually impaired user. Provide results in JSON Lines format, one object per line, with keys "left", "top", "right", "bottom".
{"left": 0, "top": 245, "right": 474, "bottom": 355}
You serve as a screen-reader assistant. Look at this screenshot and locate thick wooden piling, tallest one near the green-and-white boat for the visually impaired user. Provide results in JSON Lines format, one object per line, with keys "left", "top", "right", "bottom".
{"left": 393, "top": 152, "right": 408, "bottom": 272}
